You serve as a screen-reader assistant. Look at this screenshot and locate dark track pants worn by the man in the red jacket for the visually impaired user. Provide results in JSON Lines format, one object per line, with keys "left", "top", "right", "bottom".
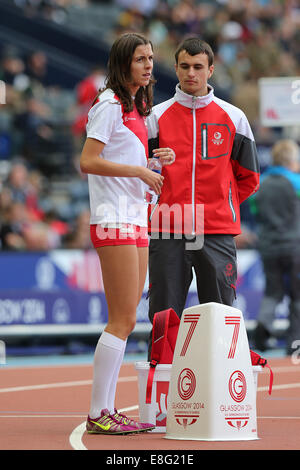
{"left": 149, "top": 235, "right": 237, "bottom": 354}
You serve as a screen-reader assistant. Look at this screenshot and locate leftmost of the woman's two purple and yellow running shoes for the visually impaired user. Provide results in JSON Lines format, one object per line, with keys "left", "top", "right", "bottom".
{"left": 86, "top": 409, "right": 137, "bottom": 435}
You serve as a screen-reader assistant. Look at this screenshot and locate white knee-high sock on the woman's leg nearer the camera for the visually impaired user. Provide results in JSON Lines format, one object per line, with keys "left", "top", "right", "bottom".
{"left": 89, "top": 331, "right": 126, "bottom": 418}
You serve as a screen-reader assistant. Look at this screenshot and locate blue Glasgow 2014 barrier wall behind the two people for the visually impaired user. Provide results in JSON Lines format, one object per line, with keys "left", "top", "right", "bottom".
{"left": 0, "top": 250, "right": 287, "bottom": 332}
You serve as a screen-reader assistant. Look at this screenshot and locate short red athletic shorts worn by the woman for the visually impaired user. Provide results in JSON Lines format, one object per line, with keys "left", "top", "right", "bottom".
{"left": 90, "top": 224, "right": 149, "bottom": 248}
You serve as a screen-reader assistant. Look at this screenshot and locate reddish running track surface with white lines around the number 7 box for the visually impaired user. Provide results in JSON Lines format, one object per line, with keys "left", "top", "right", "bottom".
{"left": 0, "top": 357, "right": 300, "bottom": 455}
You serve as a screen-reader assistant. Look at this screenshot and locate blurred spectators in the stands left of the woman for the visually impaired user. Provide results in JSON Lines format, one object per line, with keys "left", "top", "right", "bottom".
{"left": 0, "top": 42, "right": 103, "bottom": 251}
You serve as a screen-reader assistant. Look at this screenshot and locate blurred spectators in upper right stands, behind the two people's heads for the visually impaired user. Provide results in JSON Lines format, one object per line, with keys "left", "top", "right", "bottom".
{"left": 115, "top": 0, "right": 300, "bottom": 138}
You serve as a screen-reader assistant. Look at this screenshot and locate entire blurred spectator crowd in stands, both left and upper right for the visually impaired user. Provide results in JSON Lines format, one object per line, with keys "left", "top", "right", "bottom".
{"left": 0, "top": 0, "right": 300, "bottom": 250}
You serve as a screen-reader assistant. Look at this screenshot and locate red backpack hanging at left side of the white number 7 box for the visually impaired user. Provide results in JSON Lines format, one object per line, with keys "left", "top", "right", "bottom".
{"left": 146, "top": 308, "right": 180, "bottom": 403}
